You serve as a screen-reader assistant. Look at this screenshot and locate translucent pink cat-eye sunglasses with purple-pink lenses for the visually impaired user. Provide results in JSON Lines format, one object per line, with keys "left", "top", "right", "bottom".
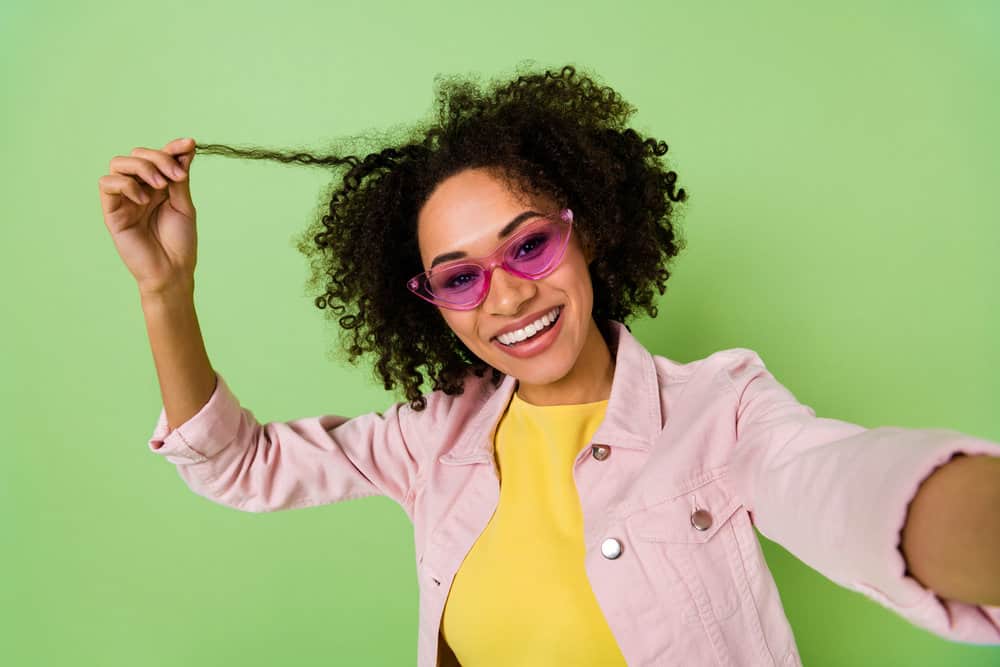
{"left": 406, "top": 208, "right": 573, "bottom": 310}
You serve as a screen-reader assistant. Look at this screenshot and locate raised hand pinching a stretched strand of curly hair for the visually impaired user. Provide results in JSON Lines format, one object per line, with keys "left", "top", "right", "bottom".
{"left": 97, "top": 139, "right": 198, "bottom": 294}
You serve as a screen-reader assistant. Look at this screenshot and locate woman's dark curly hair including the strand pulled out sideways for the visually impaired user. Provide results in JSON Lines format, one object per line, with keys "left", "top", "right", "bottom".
{"left": 190, "top": 65, "right": 687, "bottom": 411}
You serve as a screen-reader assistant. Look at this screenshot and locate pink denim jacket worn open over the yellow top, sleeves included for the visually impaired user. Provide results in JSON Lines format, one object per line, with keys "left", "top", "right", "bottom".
{"left": 149, "top": 322, "right": 1000, "bottom": 667}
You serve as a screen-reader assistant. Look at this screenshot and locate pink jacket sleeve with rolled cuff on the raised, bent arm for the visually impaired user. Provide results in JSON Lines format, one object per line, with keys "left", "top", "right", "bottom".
{"left": 149, "top": 372, "right": 419, "bottom": 516}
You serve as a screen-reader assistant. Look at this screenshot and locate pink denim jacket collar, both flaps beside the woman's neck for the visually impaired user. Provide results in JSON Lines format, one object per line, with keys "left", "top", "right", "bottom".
{"left": 438, "top": 320, "right": 663, "bottom": 465}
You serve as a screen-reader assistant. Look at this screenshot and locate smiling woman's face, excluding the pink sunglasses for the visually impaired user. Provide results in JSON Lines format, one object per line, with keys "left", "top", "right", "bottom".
{"left": 414, "top": 168, "right": 594, "bottom": 385}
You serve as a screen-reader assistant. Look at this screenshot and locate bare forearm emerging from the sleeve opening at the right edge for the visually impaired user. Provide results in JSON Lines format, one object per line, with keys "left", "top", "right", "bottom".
{"left": 900, "top": 455, "right": 1000, "bottom": 606}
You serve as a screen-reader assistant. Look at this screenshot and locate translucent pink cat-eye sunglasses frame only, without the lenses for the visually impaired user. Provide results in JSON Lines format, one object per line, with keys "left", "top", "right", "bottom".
{"left": 406, "top": 208, "right": 573, "bottom": 310}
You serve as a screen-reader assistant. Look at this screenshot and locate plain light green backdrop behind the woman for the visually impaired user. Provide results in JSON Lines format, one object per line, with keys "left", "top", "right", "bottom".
{"left": 0, "top": 0, "right": 1000, "bottom": 667}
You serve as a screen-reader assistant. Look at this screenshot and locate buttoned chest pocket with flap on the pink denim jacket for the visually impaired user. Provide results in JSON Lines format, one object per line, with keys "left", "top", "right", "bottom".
{"left": 626, "top": 480, "right": 749, "bottom": 623}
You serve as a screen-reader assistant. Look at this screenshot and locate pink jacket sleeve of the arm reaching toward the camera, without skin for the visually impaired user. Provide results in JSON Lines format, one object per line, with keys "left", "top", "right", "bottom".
{"left": 727, "top": 348, "right": 1000, "bottom": 644}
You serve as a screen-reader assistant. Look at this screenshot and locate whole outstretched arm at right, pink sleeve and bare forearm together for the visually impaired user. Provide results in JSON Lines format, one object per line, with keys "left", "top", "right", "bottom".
{"left": 726, "top": 348, "right": 1000, "bottom": 644}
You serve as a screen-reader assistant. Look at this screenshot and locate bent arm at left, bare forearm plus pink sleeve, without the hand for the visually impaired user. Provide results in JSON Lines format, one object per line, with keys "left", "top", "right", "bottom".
{"left": 143, "top": 288, "right": 418, "bottom": 514}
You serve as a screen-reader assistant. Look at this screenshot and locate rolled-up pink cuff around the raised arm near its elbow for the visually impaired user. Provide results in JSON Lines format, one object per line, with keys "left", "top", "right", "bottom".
{"left": 149, "top": 372, "right": 242, "bottom": 465}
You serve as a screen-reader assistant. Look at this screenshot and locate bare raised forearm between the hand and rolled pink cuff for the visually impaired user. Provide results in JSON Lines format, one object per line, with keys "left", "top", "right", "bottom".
{"left": 140, "top": 285, "right": 216, "bottom": 430}
